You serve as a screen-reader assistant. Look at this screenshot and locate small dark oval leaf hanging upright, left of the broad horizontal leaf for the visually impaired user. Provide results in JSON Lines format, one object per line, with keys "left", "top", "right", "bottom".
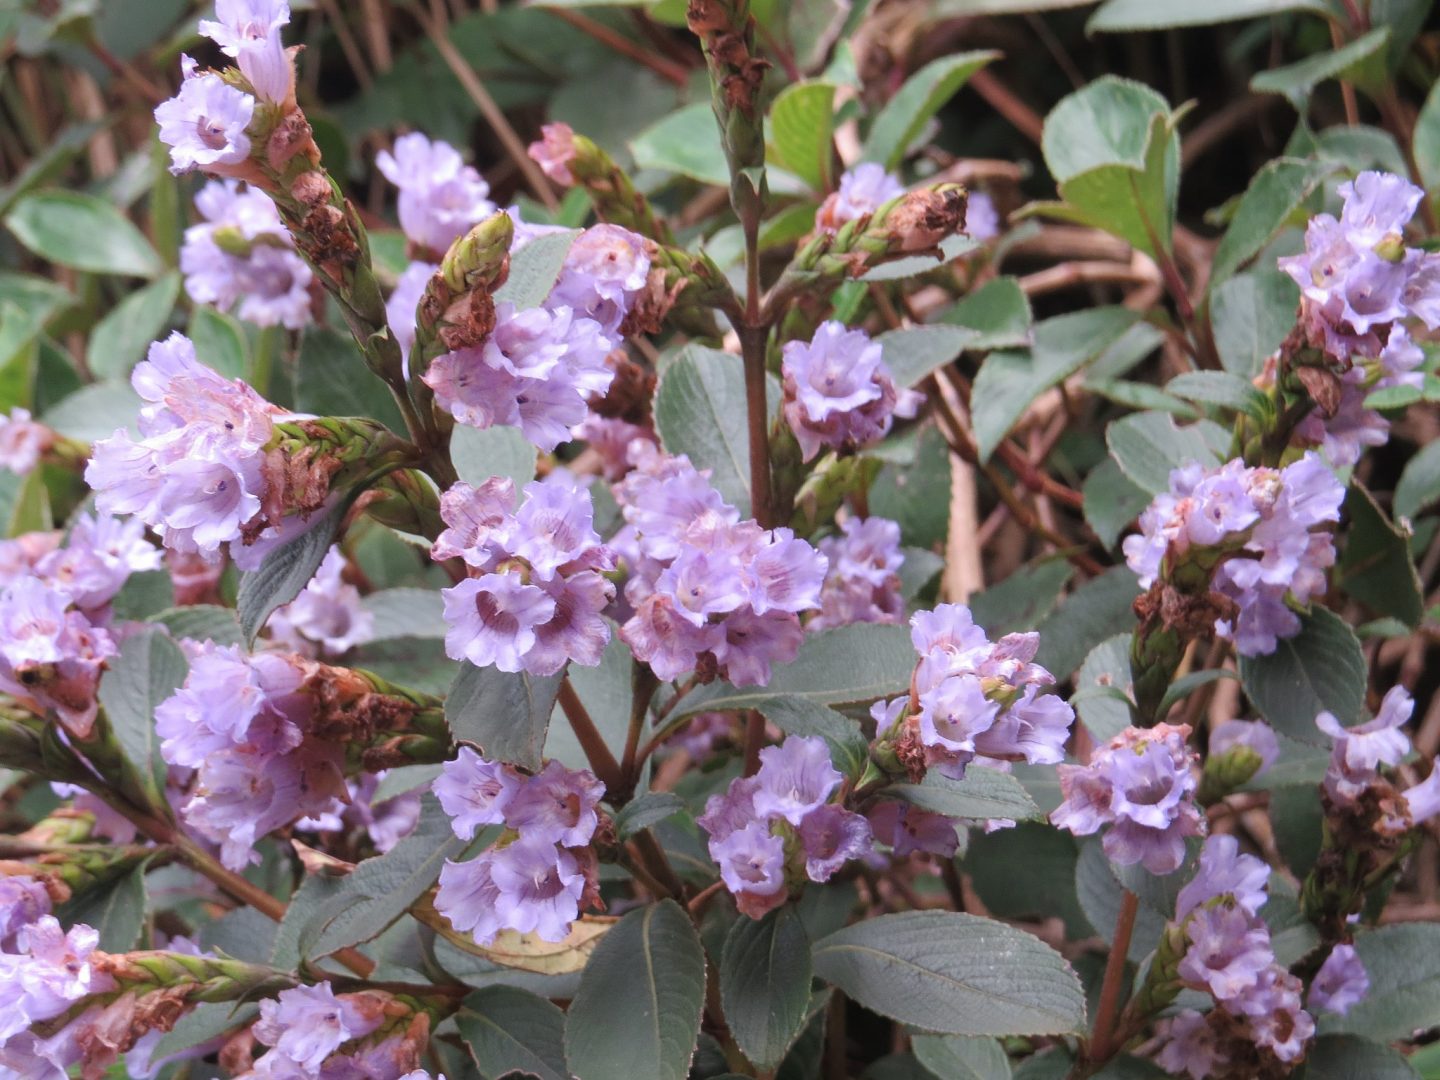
{"left": 720, "top": 904, "right": 811, "bottom": 1070}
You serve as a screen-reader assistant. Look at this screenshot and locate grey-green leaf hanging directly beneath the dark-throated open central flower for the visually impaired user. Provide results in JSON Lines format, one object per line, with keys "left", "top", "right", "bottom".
{"left": 445, "top": 662, "right": 563, "bottom": 769}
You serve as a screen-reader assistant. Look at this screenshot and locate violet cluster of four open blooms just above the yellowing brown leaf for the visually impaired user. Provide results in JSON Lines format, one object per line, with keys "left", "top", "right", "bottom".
{"left": 433, "top": 746, "right": 605, "bottom": 945}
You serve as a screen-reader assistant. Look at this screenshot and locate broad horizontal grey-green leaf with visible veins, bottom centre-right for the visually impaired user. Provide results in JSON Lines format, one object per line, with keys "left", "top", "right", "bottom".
{"left": 814, "top": 912, "right": 1084, "bottom": 1035}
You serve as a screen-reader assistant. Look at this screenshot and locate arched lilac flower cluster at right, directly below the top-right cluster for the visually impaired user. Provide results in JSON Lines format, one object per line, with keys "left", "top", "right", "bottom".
{"left": 1123, "top": 454, "right": 1345, "bottom": 657}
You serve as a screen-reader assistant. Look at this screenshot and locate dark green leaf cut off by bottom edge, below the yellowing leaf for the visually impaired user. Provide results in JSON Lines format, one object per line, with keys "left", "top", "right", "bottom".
{"left": 455, "top": 986, "right": 570, "bottom": 1080}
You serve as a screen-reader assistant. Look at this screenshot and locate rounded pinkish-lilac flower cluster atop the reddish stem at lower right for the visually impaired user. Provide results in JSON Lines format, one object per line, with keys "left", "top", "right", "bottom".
{"left": 1050, "top": 724, "right": 1205, "bottom": 874}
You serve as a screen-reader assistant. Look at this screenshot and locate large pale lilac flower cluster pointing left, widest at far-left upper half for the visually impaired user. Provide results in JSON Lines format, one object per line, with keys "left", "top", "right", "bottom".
{"left": 85, "top": 333, "right": 285, "bottom": 569}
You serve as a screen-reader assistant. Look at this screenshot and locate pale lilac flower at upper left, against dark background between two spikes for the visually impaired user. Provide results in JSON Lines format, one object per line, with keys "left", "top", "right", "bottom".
{"left": 374, "top": 131, "right": 495, "bottom": 255}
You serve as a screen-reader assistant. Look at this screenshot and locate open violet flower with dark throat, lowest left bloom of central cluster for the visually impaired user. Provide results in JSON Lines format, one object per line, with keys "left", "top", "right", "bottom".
{"left": 441, "top": 573, "right": 554, "bottom": 671}
